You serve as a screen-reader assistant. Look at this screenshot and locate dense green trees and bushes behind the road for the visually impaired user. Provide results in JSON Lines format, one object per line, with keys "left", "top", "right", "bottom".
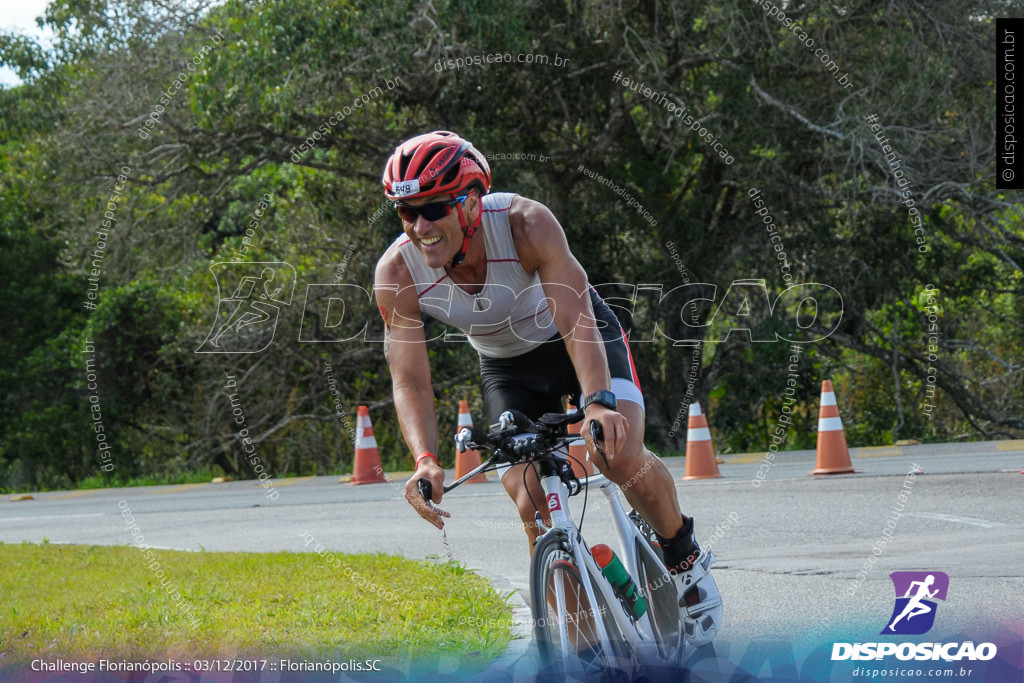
{"left": 0, "top": 0, "right": 1024, "bottom": 489}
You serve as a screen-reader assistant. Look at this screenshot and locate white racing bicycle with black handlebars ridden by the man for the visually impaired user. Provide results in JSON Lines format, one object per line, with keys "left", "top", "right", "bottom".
{"left": 418, "top": 411, "right": 696, "bottom": 675}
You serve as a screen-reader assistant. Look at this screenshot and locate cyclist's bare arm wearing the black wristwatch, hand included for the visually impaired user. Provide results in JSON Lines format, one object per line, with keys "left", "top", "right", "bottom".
{"left": 509, "top": 197, "right": 629, "bottom": 456}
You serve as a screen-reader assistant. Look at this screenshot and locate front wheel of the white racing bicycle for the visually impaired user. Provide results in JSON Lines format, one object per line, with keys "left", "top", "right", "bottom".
{"left": 529, "top": 531, "right": 628, "bottom": 675}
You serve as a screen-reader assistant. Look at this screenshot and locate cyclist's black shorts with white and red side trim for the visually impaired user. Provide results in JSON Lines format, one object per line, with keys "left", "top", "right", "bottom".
{"left": 480, "top": 287, "right": 643, "bottom": 424}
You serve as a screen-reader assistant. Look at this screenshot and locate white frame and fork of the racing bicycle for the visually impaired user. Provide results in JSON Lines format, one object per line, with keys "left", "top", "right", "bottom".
{"left": 537, "top": 474, "right": 656, "bottom": 656}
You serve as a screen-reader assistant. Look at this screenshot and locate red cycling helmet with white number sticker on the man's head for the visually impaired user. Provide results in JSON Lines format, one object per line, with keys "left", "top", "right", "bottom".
{"left": 381, "top": 130, "right": 490, "bottom": 202}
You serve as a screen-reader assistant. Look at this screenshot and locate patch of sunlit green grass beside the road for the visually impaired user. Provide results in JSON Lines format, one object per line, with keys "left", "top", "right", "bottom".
{"left": 0, "top": 543, "right": 511, "bottom": 669}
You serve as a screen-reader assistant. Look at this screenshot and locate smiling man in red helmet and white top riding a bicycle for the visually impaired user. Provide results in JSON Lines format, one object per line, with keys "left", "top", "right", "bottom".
{"left": 374, "top": 131, "right": 722, "bottom": 645}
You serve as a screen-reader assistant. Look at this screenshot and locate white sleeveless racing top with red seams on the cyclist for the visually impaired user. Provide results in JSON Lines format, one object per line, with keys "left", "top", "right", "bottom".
{"left": 395, "top": 193, "right": 558, "bottom": 358}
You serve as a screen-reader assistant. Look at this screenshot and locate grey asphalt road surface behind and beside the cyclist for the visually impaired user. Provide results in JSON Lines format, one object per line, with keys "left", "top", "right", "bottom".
{"left": 0, "top": 441, "right": 1024, "bottom": 679}
